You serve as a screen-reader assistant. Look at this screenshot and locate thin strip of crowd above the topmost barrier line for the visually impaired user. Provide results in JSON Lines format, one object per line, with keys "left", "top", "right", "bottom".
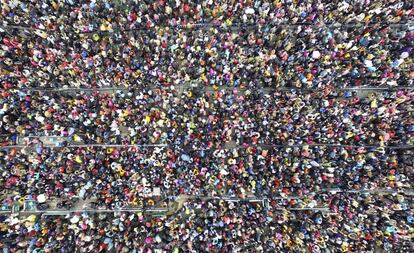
{"left": 0, "top": 0, "right": 413, "bottom": 28}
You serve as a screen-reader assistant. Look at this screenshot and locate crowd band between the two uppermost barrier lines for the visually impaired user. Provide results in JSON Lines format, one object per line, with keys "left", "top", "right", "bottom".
{"left": 0, "top": 12, "right": 414, "bottom": 89}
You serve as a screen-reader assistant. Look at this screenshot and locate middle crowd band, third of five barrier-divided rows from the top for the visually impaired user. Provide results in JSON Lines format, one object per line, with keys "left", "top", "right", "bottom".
{"left": 0, "top": 87, "right": 414, "bottom": 147}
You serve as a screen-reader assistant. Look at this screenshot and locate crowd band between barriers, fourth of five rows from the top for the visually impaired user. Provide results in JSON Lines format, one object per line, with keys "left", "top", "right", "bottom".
{"left": 1, "top": 133, "right": 413, "bottom": 208}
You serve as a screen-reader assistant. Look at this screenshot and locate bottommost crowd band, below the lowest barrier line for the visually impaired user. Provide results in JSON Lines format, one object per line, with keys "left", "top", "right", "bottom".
{"left": 0, "top": 193, "right": 414, "bottom": 253}
